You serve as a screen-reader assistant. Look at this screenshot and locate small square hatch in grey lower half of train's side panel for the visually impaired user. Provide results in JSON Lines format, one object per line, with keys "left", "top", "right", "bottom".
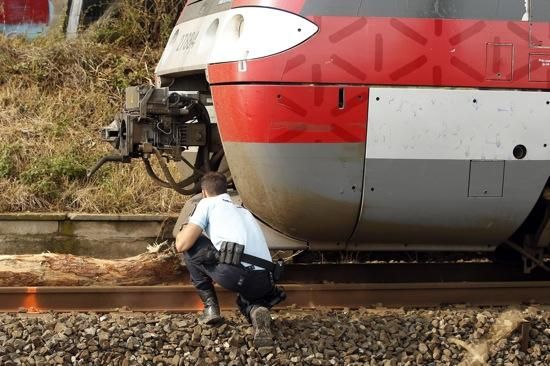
{"left": 468, "top": 161, "right": 504, "bottom": 197}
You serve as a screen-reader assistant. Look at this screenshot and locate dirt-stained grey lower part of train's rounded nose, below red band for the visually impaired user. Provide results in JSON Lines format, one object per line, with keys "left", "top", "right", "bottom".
{"left": 224, "top": 142, "right": 365, "bottom": 242}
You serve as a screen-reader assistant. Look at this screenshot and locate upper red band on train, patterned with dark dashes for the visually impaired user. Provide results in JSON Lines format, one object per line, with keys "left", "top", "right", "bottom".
{"left": 209, "top": 17, "right": 550, "bottom": 89}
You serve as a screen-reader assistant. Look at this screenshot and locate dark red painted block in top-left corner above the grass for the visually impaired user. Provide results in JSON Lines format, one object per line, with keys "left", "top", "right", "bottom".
{"left": 0, "top": 0, "right": 50, "bottom": 25}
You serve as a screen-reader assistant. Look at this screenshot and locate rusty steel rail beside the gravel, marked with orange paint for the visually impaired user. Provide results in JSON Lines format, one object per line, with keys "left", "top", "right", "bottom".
{"left": 0, "top": 281, "right": 550, "bottom": 312}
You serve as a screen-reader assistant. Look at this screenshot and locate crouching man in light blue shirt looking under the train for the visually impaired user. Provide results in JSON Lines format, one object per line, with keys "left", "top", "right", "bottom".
{"left": 176, "top": 173, "right": 286, "bottom": 347}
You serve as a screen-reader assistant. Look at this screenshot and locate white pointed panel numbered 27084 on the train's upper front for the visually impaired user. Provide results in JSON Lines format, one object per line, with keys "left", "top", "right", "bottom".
{"left": 156, "top": 7, "right": 319, "bottom": 75}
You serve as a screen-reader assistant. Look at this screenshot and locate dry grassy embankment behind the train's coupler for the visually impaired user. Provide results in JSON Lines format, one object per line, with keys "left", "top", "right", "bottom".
{"left": 0, "top": 0, "right": 185, "bottom": 213}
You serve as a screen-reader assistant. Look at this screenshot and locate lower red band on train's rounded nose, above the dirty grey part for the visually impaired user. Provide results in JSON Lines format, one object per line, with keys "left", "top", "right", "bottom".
{"left": 212, "top": 85, "right": 369, "bottom": 143}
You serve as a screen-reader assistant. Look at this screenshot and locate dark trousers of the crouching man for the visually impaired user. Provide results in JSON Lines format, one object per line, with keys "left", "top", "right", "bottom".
{"left": 183, "top": 236, "right": 278, "bottom": 321}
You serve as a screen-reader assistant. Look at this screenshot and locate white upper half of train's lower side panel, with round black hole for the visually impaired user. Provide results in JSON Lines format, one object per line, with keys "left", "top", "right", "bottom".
{"left": 367, "top": 88, "right": 550, "bottom": 160}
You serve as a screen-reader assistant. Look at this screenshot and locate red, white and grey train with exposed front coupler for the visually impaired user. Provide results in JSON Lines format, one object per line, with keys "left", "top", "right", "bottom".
{"left": 90, "top": 0, "right": 550, "bottom": 271}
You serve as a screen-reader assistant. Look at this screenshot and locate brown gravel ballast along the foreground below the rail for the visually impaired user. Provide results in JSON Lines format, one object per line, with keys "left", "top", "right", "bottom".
{"left": 0, "top": 306, "right": 550, "bottom": 366}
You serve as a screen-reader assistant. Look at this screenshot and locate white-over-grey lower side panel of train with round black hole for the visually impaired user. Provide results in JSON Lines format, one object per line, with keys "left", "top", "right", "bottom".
{"left": 351, "top": 88, "right": 550, "bottom": 250}
